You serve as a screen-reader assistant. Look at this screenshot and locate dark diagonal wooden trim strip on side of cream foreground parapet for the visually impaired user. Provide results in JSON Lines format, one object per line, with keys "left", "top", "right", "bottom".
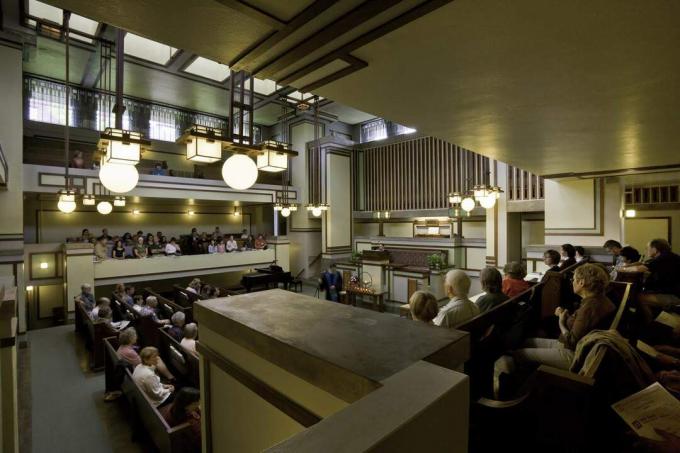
{"left": 196, "top": 343, "right": 321, "bottom": 428}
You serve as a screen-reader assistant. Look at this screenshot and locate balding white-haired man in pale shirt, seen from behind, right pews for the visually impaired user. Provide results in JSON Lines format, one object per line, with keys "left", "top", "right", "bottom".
{"left": 433, "top": 269, "right": 479, "bottom": 327}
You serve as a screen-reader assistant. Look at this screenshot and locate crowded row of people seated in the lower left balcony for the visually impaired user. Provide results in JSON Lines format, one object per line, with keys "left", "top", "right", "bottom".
{"left": 67, "top": 226, "right": 267, "bottom": 261}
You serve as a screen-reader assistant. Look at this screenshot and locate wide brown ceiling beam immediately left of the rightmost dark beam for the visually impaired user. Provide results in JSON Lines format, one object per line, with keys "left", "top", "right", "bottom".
{"left": 253, "top": 0, "right": 402, "bottom": 79}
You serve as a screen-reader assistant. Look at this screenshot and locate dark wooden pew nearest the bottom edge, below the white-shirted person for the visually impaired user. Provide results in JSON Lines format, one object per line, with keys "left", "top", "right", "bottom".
{"left": 122, "top": 358, "right": 197, "bottom": 453}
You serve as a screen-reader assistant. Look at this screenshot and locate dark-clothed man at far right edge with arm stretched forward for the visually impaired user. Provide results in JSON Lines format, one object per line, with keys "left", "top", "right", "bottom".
{"left": 621, "top": 239, "right": 680, "bottom": 309}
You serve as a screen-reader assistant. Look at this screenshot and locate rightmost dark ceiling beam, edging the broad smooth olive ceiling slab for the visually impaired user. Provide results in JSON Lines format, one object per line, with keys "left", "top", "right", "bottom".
{"left": 278, "top": 0, "right": 453, "bottom": 85}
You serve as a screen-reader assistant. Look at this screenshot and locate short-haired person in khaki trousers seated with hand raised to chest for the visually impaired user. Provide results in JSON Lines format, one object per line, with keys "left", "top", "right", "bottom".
{"left": 502, "top": 264, "right": 616, "bottom": 370}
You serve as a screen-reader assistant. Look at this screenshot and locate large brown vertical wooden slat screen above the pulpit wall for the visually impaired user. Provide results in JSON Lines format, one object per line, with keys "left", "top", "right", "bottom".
{"left": 357, "top": 137, "right": 490, "bottom": 211}
